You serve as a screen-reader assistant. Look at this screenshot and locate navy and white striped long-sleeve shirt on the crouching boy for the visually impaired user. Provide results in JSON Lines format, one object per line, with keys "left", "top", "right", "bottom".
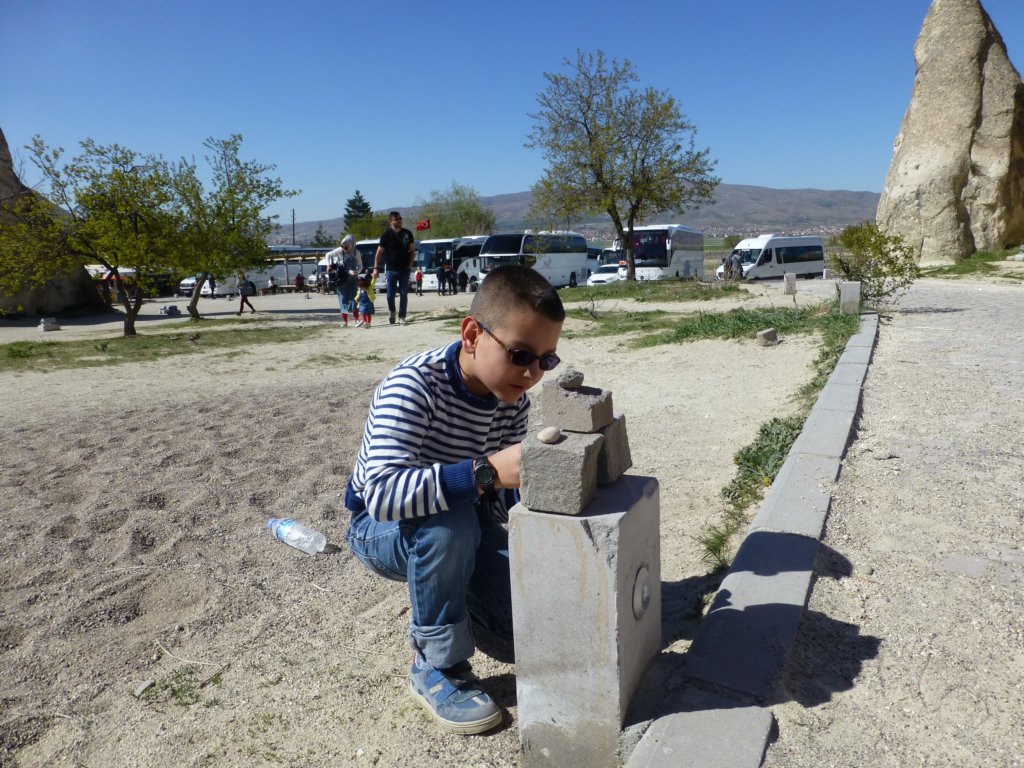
{"left": 351, "top": 341, "right": 529, "bottom": 522}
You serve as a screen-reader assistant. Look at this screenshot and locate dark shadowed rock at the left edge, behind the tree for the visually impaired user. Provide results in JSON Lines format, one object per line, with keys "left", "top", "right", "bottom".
{"left": 0, "top": 130, "right": 110, "bottom": 315}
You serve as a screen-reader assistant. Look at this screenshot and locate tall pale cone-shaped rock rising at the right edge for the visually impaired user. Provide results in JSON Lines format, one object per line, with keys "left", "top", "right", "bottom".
{"left": 877, "top": 0, "right": 1024, "bottom": 265}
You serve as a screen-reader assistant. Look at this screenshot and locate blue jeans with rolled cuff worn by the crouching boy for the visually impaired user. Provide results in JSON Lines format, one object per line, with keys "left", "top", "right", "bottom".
{"left": 345, "top": 504, "right": 512, "bottom": 669}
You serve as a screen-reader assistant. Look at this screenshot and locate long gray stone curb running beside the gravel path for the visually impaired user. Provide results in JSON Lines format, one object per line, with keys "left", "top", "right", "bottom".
{"left": 626, "top": 314, "right": 879, "bottom": 768}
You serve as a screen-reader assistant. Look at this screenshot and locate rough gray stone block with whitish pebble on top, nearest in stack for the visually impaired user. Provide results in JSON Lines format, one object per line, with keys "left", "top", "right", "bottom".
{"left": 519, "top": 432, "right": 604, "bottom": 515}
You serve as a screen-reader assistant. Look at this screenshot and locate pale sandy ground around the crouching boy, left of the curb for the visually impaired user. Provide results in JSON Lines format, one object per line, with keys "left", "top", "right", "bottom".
{"left": 0, "top": 282, "right": 831, "bottom": 768}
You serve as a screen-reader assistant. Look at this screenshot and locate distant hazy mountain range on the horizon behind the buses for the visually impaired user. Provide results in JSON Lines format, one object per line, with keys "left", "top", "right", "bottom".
{"left": 271, "top": 184, "right": 881, "bottom": 244}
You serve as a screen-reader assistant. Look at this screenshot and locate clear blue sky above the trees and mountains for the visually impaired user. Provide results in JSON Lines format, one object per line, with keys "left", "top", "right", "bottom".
{"left": 0, "top": 0, "right": 1024, "bottom": 224}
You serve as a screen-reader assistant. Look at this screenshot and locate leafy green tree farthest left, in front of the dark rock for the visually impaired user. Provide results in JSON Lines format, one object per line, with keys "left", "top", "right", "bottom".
{"left": 0, "top": 136, "right": 180, "bottom": 336}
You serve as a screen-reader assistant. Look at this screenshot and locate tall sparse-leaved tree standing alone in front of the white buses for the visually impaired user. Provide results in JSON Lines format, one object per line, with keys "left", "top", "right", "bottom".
{"left": 526, "top": 50, "right": 719, "bottom": 280}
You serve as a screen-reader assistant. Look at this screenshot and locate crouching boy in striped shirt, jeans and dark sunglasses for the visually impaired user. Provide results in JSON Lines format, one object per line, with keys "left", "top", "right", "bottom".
{"left": 345, "top": 265, "right": 565, "bottom": 733}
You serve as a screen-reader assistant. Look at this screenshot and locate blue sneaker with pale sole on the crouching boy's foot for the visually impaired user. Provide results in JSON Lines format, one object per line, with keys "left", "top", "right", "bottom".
{"left": 409, "top": 653, "right": 502, "bottom": 733}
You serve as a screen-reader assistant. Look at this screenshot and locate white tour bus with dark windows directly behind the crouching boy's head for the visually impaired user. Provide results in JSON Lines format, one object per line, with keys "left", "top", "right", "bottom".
{"left": 458, "top": 231, "right": 588, "bottom": 291}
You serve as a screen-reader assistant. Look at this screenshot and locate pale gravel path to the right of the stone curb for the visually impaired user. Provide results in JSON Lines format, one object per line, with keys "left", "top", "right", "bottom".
{"left": 764, "top": 281, "right": 1024, "bottom": 768}
